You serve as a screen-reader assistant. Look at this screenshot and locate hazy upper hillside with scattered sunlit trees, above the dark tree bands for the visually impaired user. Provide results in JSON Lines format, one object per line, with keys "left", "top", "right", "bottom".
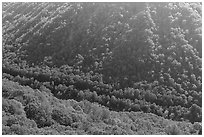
{"left": 3, "top": 3, "right": 202, "bottom": 89}
